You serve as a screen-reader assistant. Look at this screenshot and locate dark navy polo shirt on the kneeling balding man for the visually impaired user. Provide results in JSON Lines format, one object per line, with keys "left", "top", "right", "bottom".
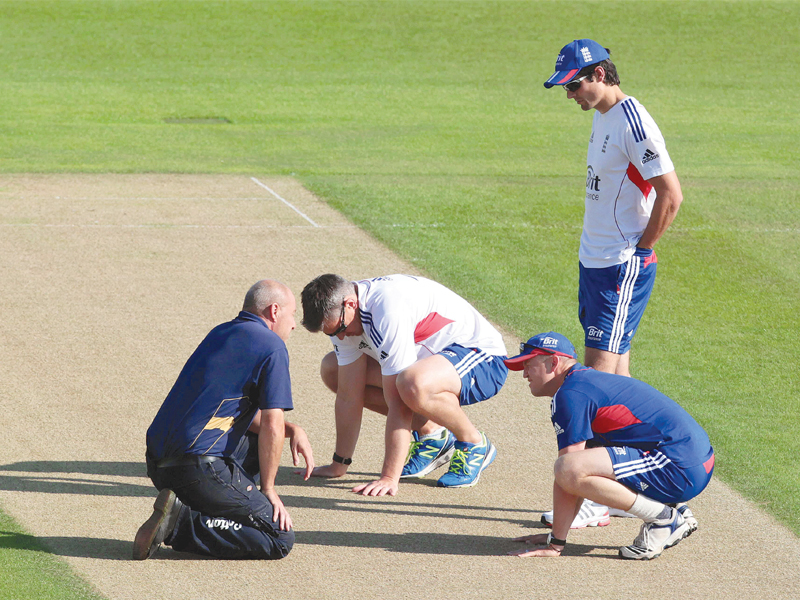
{"left": 147, "top": 311, "right": 294, "bottom": 460}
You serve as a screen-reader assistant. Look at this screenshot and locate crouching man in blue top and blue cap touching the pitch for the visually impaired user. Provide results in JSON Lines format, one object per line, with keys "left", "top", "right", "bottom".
{"left": 505, "top": 331, "right": 714, "bottom": 560}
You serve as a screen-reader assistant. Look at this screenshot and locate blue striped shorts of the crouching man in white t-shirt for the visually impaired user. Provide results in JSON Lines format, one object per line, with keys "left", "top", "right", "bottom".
{"left": 439, "top": 344, "right": 508, "bottom": 406}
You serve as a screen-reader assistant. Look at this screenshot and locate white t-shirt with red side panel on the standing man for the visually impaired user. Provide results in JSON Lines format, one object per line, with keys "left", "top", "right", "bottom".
{"left": 579, "top": 96, "right": 675, "bottom": 269}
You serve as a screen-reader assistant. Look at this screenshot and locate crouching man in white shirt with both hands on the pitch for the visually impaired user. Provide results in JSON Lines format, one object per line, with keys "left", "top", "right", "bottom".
{"left": 301, "top": 274, "right": 508, "bottom": 496}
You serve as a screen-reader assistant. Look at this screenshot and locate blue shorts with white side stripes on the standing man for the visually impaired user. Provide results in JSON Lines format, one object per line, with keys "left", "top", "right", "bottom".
{"left": 578, "top": 248, "right": 658, "bottom": 354}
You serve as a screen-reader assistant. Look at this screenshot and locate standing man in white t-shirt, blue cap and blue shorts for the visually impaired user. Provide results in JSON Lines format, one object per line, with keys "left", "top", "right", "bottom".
{"left": 542, "top": 39, "right": 683, "bottom": 527}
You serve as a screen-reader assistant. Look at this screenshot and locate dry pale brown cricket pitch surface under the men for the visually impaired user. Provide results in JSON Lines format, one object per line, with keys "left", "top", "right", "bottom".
{"left": 0, "top": 175, "right": 800, "bottom": 600}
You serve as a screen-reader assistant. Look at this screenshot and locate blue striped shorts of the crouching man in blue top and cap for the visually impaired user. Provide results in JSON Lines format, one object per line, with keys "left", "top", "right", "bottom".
{"left": 606, "top": 446, "right": 714, "bottom": 504}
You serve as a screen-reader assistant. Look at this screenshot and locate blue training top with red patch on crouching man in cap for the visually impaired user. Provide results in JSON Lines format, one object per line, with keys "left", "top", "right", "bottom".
{"left": 551, "top": 364, "right": 713, "bottom": 468}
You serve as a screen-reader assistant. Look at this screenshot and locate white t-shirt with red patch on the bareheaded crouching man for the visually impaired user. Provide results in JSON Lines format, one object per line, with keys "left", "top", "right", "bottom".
{"left": 331, "top": 275, "right": 506, "bottom": 375}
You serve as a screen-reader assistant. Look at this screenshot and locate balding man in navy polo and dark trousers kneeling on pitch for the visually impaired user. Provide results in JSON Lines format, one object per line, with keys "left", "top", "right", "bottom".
{"left": 133, "top": 280, "right": 314, "bottom": 560}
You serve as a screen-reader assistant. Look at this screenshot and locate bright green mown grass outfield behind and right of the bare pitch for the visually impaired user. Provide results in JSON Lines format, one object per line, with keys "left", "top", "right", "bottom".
{"left": 0, "top": 1, "right": 800, "bottom": 593}
